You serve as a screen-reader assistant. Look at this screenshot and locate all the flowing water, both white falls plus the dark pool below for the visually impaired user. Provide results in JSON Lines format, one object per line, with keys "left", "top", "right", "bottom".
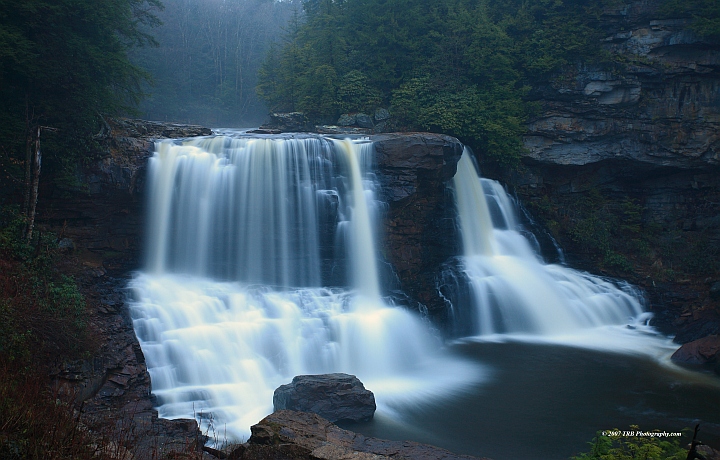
{"left": 131, "top": 136, "right": 720, "bottom": 459}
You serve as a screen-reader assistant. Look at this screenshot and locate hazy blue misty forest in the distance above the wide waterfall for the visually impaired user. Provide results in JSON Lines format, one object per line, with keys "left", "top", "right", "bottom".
{"left": 131, "top": 0, "right": 301, "bottom": 127}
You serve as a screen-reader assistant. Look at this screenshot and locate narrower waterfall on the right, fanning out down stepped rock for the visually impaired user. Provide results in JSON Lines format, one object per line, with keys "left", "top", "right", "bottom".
{"left": 453, "top": 149, "right": 646, "bottom": 336}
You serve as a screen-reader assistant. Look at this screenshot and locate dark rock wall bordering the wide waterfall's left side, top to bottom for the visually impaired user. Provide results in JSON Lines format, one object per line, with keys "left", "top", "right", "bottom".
{"left": 39, "top": 120, "right": 211, "bottom": 460}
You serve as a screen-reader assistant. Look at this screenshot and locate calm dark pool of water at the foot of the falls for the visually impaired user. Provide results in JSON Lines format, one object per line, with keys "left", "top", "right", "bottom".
{"left": 345, "top": 342, "right": 720, "bottom": 460}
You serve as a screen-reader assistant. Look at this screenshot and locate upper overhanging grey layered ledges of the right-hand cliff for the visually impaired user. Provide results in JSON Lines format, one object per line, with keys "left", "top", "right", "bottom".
{"left": 525, "top": 1, "right": 720, "bottom": 169}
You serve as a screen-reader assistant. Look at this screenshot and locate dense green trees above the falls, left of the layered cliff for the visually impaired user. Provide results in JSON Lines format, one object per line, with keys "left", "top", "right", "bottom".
{"left": 258, "top": 0, "right": 612, "bottom": 164}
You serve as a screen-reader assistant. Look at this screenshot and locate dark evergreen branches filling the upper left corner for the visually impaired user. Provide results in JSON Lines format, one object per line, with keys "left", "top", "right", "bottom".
{"left": 0, "top": 0, "right": 161, "bottom": 196}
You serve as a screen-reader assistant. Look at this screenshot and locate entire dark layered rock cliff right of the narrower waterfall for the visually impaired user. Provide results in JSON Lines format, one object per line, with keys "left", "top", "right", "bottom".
{"left": 504, "top": 0, "right": 720, "bottom": 342}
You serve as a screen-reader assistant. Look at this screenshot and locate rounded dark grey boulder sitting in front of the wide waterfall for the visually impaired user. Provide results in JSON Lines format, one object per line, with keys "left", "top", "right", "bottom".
{"left": 273, "top": 374, "right": 375, "bottom": 422}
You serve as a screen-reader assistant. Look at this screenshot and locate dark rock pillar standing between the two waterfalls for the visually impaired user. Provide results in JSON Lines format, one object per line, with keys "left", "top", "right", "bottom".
{"left": 372, "top": 133, "right": 463, "bottom": 316}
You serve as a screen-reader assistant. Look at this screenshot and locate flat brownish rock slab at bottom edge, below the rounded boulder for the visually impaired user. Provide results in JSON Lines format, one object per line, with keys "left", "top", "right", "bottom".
{"left": 227, "top": 410, "right": 490, "bottom": 460}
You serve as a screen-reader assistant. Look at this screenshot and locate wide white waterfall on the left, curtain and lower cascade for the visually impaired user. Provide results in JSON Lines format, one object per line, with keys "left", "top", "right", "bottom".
{"left": 131, "top": 136, "right": 479, "bottom": 439}
